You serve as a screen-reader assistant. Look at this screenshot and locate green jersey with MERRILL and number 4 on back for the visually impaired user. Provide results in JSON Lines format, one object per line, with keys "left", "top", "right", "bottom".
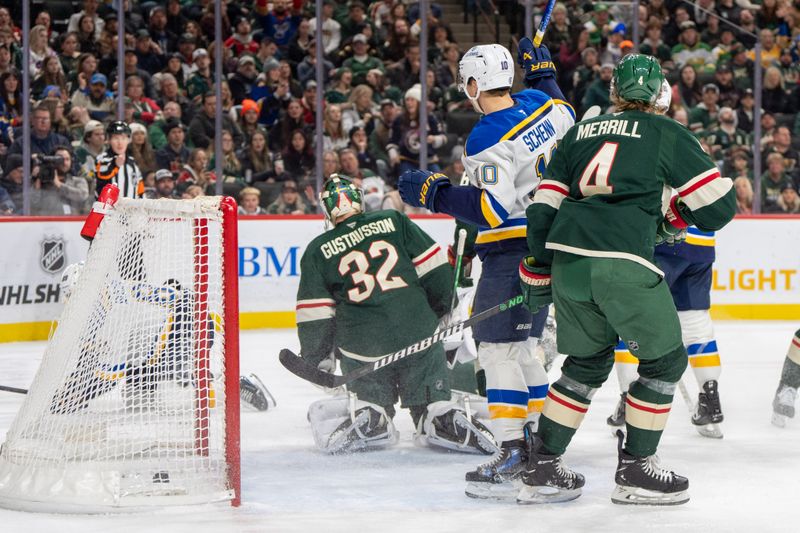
{"left": 526, "top": 111, "right": 736, "bottom": 273}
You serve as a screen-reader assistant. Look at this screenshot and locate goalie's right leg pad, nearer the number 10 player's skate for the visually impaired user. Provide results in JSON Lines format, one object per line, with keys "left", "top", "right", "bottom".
{"left": 416, "top": 401, "right": 499, "bottom": 455}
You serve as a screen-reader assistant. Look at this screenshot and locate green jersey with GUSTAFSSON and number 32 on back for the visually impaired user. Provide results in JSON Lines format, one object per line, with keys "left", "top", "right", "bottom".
{"left": 296, "top": 210, "right": 453, "bottom": 364}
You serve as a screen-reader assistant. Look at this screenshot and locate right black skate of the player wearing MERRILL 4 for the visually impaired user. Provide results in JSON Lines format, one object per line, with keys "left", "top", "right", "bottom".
{"left": 611, "top": 430, "right": 689, "bottom": 505}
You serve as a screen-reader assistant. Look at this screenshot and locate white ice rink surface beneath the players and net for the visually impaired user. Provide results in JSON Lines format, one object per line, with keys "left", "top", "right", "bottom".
{"left": 0, "top": 322, "right": 800, "bottom": 533}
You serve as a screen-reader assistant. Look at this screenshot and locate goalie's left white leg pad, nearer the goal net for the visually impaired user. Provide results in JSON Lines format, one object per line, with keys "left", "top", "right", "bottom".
{"left": 308, "top": 393, "right": 398, "bottom": 454}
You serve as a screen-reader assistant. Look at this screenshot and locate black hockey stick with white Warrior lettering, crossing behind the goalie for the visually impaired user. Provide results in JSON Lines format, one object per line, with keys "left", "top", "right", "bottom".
{"left": 278, "top": 295, "right": 522, "bottom": 389}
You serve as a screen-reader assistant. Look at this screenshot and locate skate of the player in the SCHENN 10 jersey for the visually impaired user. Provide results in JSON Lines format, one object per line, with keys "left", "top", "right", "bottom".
{"left": 464, "top": 439, "right": 528, "bottom": 500}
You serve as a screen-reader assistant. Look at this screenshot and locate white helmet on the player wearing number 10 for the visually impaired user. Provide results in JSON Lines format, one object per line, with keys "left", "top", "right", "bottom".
{"left": 458, "top": 44, "right": 514, "bottom": 114}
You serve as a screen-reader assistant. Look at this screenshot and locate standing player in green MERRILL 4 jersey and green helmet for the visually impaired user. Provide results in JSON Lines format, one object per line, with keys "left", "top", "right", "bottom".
{"left": 518, "top": 54, "right": 735, "bottom": 505}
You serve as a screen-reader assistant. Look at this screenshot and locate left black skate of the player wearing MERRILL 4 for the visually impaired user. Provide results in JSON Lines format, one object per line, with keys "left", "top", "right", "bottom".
{"left": 517, "top": 427, "right": 586, "bottom": 504}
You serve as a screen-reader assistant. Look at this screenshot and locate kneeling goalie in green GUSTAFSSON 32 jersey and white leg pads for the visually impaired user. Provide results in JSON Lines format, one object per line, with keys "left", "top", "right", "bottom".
{"left": 296, "top": 174, "right": 497, "bottom": 454}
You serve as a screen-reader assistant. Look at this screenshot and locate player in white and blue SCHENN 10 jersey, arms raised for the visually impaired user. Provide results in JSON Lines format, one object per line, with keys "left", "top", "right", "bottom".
{"left": 398, "top": 38, "right": 575, "bottom": 499}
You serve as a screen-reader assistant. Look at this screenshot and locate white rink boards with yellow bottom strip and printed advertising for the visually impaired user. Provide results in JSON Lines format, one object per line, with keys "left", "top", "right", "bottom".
{"left": 0, "top": 215, "right": 800, "bottom": 342}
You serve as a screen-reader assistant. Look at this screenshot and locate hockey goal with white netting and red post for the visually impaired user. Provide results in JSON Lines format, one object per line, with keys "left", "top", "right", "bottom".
{"left": 0, "top": 197, "right": 239, "bottom": 512}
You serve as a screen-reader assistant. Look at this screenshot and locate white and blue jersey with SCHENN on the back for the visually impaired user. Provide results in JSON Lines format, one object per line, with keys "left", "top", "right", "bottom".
{"left": 454, "top": 89, "right": 575, "bottom": 255}
